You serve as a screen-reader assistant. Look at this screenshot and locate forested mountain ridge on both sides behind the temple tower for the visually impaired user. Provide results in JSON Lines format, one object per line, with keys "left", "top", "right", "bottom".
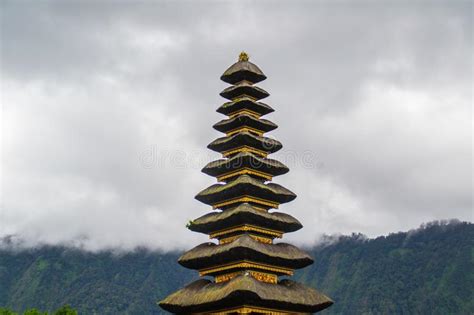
{"left": 0, "top": 221, "right": 474, "bottom": 314}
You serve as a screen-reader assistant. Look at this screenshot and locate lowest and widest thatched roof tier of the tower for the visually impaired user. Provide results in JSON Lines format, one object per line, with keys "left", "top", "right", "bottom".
{"left": 159, "top": 274, "right": 333, "bottom": 314}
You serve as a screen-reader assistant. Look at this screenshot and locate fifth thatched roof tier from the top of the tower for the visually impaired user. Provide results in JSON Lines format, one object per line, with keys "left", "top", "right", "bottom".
{"left": 207, "top": 131, "right": 283, "bottom": 155}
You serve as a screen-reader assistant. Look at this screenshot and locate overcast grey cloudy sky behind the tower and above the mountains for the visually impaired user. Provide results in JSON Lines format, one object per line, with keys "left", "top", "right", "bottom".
{"left": 0, "top": 1, "right": 473, "bottom": 250}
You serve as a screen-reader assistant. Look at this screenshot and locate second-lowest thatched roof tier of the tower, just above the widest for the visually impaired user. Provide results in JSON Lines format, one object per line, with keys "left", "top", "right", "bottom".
{"left": 178, "top": 234, "right": 313, "bottom": 270}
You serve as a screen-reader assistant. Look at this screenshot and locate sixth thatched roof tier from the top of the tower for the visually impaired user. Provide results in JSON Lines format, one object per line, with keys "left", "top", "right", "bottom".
{"left": 202, "top": 152, "right": 289, "bottom": 181}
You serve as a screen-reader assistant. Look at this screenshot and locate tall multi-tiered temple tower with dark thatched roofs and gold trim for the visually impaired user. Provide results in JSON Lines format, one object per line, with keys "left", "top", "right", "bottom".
{"left": 160, "top": 53, "right": 333, "bottom": 314}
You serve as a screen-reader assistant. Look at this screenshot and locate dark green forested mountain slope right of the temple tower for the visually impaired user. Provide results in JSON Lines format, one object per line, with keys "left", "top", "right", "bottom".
{"left": 298, "top": 223, "right": 474, "bottom": 314}
